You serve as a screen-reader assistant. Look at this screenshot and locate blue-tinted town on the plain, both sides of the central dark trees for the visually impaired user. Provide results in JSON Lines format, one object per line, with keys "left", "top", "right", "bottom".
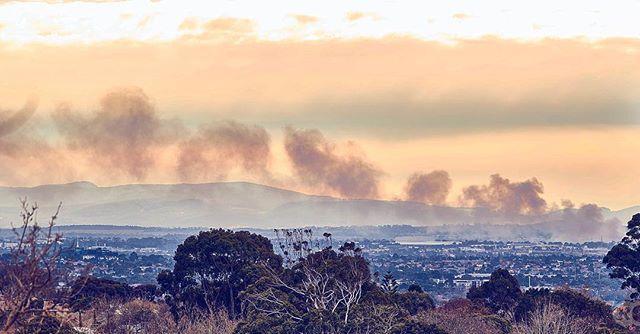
{"left": 0, "top": 235, "right": 627, "bottom": 305}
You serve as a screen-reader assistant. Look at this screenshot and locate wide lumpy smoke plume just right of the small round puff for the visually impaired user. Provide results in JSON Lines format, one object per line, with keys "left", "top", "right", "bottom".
{"left": 460, "top": 174, "right": 547, "bottom": 216}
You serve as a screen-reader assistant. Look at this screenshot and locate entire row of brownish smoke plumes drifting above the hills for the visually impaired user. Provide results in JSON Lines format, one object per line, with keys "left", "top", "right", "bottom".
{"left": 0, "top": 89, "right": 622, "bottom": 241}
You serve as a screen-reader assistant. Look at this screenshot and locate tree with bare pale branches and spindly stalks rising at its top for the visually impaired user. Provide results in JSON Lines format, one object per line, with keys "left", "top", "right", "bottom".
{"left": 244, "top": 237, "right": 371, "bottom": 323}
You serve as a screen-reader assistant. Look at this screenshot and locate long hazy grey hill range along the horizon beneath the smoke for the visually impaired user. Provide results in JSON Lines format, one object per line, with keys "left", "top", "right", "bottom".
{"left": 0, "top": 182, "right": 640, "bottom": 240}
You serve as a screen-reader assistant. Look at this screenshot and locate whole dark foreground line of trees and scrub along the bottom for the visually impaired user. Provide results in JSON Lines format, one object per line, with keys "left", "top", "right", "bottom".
{"left": 0, "top": 202, "right": 640, "bottom": 334}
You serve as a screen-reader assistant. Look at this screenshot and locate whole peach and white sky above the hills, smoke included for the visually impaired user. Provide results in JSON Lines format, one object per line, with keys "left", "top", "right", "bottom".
{"left": 0, "top": 0, "right": 640, "bottom": 211}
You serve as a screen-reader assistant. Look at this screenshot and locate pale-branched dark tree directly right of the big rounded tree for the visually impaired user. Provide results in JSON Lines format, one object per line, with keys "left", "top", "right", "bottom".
{"left": 239, "top": 242, "right": 375, "bottom": 333}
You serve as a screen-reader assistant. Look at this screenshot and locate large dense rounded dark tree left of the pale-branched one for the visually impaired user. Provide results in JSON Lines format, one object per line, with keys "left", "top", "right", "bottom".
{"left": 158, "top": 229, "right": 282, "bottom": 318}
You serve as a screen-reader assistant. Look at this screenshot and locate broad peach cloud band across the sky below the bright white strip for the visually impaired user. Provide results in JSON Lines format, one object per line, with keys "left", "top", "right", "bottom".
{"left": 0, "top": 38, "right": 640, "bottom": 139}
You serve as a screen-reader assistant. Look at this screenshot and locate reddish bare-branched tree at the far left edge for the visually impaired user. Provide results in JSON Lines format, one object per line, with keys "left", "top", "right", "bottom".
{"left": 0, "top": 198, "right": 62, "bottom": 333}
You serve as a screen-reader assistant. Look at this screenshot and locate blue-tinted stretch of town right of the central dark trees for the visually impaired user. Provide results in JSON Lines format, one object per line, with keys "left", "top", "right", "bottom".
{"left": 360, "top": 240, "right": 626, "bottom": 304}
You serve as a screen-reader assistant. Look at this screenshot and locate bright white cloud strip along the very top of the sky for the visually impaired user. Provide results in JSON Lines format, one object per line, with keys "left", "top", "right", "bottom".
{"left": 0, "top": 0, "right": 640, "bottom": 43}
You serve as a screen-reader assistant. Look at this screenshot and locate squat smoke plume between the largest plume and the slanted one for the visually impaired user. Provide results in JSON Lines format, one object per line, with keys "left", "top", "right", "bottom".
{"left": 177, "top": 121, "right": 271, "bottom": 181}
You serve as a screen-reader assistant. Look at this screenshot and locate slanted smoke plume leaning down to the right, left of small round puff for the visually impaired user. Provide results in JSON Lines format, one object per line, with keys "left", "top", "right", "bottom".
{"left": 285, "top": 127, "right": 382, "bottom": 198}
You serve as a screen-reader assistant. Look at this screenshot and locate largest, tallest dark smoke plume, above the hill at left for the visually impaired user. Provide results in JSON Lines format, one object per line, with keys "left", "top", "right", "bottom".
{"left": 54, "top": 88, "right": 177, "bottom": 180}
